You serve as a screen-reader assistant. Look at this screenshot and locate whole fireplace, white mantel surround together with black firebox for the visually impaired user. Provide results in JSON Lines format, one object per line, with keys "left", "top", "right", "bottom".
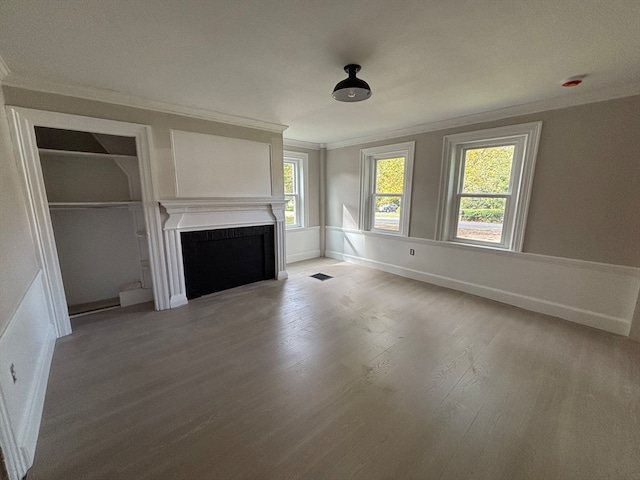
{"left": 160, "top": 197, "right": 287, "bottom": 308}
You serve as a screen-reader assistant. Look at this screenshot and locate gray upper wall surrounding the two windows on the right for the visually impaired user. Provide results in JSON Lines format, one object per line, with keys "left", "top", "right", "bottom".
{"left": 326, "top": 96, "right": 640, "bottom": 267}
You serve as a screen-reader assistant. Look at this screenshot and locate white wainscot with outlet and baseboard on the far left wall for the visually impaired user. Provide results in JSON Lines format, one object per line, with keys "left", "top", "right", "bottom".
{"left": 0, "top": 271, "right": 56, "bottom": 480}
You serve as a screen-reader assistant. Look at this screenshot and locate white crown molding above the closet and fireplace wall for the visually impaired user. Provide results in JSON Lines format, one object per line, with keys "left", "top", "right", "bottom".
{"left": 0, "top": 73, "right": 288, "bottom": 133}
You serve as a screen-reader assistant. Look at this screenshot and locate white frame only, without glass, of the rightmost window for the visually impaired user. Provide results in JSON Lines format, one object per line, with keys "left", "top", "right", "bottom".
{"left": 436, "top": 122, "right": 542, "bottom": 252}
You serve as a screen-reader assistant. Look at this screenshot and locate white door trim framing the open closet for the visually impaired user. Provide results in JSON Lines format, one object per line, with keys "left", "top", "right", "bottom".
{"left": 6, "top": 106, "right": 169, "bottom": 337}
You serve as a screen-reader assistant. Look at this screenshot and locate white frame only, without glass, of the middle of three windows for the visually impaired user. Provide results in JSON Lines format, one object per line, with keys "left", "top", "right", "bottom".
{"left": 358, "top": 141, "right": 416, "bottom": 237}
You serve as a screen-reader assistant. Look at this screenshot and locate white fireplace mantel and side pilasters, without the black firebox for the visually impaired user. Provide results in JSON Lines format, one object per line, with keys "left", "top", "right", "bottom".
{"left": 160, "top": 197, "right": 287, "bottom": 308}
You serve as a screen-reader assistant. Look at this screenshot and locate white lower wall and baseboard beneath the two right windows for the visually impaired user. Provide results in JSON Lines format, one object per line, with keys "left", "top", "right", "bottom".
{"left": 325, "top": 227, "right": 640, "bottom": 335}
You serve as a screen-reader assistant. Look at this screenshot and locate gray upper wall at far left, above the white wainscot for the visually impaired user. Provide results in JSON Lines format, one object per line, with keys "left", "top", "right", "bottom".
{"left": 0, "top": 88, "right": 38, "bottom": 334}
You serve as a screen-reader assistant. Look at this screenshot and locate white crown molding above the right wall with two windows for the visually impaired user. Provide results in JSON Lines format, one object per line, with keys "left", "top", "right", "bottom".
{"left": 326, "top": 85, "right": 640, "bottom": 150}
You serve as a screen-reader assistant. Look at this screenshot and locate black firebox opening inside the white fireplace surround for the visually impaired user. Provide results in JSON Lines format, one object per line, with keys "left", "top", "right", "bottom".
{"left": 181, "top": 225, "right": 276, "bottom": 299}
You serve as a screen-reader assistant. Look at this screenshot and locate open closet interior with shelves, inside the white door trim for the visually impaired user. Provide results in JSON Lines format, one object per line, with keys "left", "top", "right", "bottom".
{"left": 36, "top": 127, "right": 153, "bottom": 317}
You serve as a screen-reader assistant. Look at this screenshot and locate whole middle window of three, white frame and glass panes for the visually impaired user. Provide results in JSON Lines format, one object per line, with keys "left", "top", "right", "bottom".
{"left": 359, "top": 142, "right": 415, "bottom": 236}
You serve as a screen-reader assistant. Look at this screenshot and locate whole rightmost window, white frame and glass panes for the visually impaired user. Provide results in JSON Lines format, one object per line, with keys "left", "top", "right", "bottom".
{"left": 438, "top": 122, "right": 542, "bottom": 251}
